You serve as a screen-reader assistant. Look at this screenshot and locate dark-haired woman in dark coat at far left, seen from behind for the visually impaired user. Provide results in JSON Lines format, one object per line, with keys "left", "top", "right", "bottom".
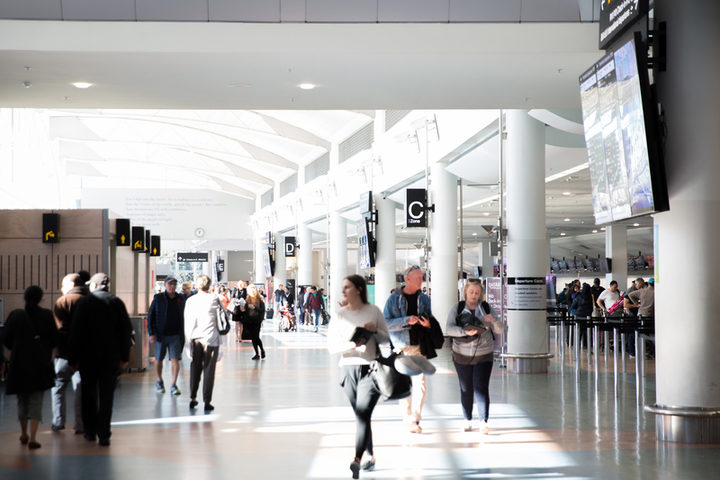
{"left": 0, "top": 285, "right": 58, "bottom": 450}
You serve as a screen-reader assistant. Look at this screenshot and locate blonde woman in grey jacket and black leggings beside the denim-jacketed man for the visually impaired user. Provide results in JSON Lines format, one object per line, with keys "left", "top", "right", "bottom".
{"left": 445, "top": 278, "right": 503, "bottom": 435}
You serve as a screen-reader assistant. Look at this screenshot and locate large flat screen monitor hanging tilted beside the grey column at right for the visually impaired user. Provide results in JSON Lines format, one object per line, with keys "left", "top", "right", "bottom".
{"left": 580, "top": 34, "right": 668, "bottom": 224}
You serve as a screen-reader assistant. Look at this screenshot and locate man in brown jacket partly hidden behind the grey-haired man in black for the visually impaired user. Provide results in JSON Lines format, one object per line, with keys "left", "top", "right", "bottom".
{"left": 50, "top": 273, "right": 86, "bottom": 433}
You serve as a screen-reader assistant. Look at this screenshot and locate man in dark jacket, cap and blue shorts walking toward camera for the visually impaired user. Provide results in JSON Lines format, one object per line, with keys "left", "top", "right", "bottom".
{"left": 148, "top": 277, "right": 185, "bottom": 395}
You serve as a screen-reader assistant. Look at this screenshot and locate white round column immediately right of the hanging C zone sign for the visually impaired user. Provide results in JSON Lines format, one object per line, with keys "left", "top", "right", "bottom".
{"left": 430, "top": 162, "right": 458, "bottom": 330}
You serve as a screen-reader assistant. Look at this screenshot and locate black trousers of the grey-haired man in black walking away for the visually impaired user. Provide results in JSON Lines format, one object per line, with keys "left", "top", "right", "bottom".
{"left": 80, "top": 365, "right": 119, "bottom": 438}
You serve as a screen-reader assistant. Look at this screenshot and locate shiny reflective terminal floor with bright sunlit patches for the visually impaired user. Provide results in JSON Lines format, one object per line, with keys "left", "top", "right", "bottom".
{"left": 0, "top": 329, "right": 720, "bottom": 480}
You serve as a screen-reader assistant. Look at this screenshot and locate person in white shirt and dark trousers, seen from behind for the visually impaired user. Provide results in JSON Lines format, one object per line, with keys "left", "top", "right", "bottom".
{"left": 185, "top": 275, "right": 223, "bottom": 412}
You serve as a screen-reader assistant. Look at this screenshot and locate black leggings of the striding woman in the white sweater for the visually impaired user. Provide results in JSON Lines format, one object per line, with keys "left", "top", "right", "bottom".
{"left": 340, "top": 365, "right": 380, "bottom": 458}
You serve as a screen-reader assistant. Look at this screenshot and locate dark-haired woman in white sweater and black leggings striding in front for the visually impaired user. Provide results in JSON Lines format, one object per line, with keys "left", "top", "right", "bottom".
{"left": 328, "top": 275, "right": 389, "bottom": 478}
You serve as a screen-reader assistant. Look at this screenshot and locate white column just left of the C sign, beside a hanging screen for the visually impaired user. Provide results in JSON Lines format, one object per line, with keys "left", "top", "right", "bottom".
{"left": 375, "top": 194, "right": 396, "bottom": 310}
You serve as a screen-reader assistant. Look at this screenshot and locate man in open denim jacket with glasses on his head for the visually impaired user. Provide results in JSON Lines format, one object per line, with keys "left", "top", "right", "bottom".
{"left": 383, "top": 265, "right": 444, "bottom": 433}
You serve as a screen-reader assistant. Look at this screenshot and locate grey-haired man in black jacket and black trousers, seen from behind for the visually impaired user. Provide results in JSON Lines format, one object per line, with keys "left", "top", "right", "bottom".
{"left": 70, "top": 273, "right": 132, "bottom": 446}
